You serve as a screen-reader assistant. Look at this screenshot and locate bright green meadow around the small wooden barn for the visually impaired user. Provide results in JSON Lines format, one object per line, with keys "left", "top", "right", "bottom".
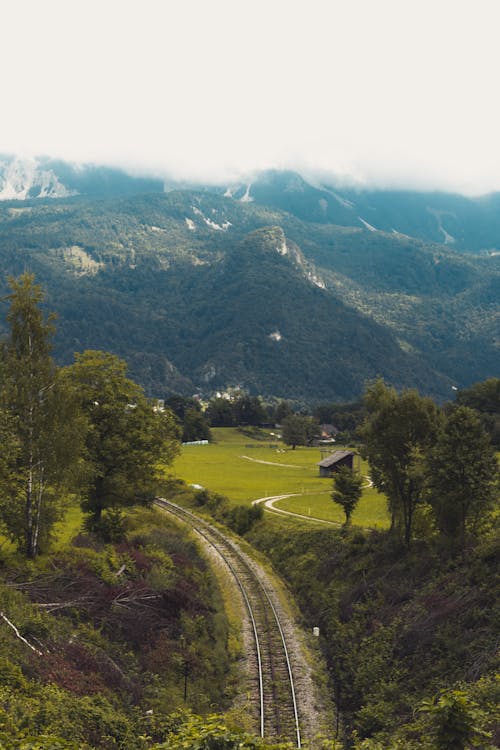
{"left": 173, "top": 427, "right": 388, "bottom": 528}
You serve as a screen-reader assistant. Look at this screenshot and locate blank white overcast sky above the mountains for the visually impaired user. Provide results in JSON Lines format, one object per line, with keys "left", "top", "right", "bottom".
{"left": 0, "top": 0, "right": 500, "bottom": 193}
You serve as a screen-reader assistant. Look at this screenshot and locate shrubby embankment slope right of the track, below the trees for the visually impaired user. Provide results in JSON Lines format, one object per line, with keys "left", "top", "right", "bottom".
{"left": 251, "top": 521, "right": 499, "bottom": 750}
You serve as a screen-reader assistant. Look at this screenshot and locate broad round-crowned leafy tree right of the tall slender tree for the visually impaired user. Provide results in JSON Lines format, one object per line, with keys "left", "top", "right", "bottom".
{"left": 64, "top": 351, "right": 178, "bottom": 531}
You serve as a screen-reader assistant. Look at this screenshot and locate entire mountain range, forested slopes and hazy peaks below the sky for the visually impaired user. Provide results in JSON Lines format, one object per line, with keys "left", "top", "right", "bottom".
{"left": 0, "top": 157, "right": 500, "bottom": 401}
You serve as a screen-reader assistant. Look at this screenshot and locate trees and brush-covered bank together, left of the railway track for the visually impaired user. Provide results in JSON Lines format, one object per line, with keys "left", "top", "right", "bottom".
{"left": 0, "top": 282, "right": 304, "bottom": 750}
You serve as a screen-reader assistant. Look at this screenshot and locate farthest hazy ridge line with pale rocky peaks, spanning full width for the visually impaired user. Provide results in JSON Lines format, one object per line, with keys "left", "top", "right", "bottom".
{"left": 4, "top": 155, "right": 500, "bottom": 254}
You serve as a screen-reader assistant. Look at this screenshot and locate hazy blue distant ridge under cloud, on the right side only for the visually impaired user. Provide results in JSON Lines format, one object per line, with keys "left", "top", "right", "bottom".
{"left": 219, "top": 170, "right": 500, "bottom": 252}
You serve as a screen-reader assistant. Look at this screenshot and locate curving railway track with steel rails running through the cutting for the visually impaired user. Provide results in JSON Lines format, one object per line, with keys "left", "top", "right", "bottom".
{"left": 155, "top": 498, "right": 301, "bottom": 748}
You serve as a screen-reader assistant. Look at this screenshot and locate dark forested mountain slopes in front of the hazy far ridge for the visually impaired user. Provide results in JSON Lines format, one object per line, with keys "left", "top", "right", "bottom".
{"left": 0, "top": 191, "right": 500, "bottom": 402}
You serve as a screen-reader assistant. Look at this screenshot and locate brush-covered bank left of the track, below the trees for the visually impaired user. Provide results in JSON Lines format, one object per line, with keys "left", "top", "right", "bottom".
{"left": 0, "top": 508, "right": 231, "bottom": 750}
